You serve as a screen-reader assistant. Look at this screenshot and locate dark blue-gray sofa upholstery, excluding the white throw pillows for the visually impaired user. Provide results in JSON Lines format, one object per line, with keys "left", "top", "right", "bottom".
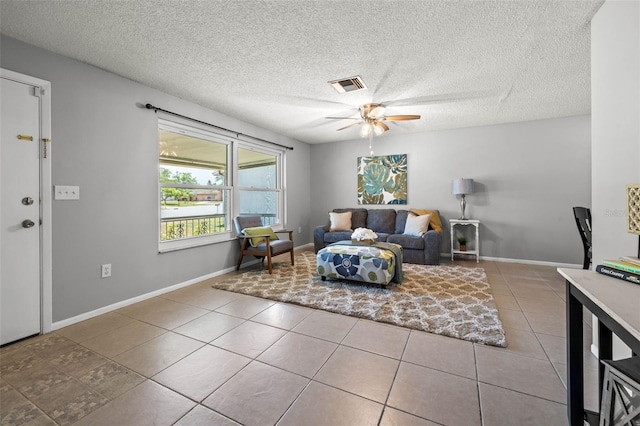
{"left": 313, "top": 208, "right": 442, "bottom": 265}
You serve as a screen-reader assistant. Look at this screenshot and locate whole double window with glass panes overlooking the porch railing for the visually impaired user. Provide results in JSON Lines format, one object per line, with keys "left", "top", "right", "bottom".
{"left": 158, "top": 120, "right": 284, "bottom": 251}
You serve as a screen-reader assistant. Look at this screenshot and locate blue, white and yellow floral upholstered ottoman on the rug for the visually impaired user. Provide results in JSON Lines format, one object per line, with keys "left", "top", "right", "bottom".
{"left": 316, "top": 241, "right": 402, "bottom": 285}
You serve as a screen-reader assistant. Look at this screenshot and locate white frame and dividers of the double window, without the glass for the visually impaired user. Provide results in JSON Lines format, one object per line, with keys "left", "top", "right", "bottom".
{"left": 156, "top": 117, "right": 286, "bottom": 253}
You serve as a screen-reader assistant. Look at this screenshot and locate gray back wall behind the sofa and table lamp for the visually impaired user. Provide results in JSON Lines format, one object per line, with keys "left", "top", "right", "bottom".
{"left": 311, "top": 116, "right": 591, "bottom": 264}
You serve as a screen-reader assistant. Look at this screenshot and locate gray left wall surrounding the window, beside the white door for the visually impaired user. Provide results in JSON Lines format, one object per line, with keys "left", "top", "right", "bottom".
{"left": 0, "top": 37, "right": 311, "bottom": 322}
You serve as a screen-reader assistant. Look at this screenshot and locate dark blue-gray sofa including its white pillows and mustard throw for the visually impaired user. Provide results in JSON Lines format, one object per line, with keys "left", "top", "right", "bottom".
{"left": 313, "top": 208, "right": 442, "bottom": 265}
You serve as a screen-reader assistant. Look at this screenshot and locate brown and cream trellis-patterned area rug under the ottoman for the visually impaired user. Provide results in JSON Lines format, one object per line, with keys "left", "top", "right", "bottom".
{"left": 212, "top": 252, "right": 507, "bottom": 347}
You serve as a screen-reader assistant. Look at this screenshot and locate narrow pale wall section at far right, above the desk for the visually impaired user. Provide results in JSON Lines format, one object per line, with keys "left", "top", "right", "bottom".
{"left": 591, "top": 1, "right": 640, "bottom": 265}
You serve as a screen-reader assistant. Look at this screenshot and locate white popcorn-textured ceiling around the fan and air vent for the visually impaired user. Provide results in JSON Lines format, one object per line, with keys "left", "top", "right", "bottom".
{"left": 0, "top": 0, "right": 604, "bottom": 143}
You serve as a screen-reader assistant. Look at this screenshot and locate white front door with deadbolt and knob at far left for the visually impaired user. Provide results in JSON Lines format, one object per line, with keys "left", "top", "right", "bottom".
{"left": 0, "top": 78, "right": 42, "bottom": 344}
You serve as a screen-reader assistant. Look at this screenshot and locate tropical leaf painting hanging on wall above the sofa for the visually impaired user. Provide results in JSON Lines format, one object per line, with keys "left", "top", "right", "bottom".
{"left": 357, "top": 154, "right": 407, "bottom": 204}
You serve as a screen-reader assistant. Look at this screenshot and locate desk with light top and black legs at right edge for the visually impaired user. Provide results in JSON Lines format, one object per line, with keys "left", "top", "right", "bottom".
{"left": 558, "top": 268, "right": 640, "bottom": 426}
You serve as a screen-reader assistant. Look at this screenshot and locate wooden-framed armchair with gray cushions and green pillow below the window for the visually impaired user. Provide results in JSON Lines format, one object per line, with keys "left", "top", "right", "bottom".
{"left": 233, "top": 216, "right": 294, "bottom": 274}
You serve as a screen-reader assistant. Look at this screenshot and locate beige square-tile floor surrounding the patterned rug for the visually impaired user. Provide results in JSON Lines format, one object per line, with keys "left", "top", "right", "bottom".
{"left": 0, "top": 251, "right": 597, "bottom": 426}
